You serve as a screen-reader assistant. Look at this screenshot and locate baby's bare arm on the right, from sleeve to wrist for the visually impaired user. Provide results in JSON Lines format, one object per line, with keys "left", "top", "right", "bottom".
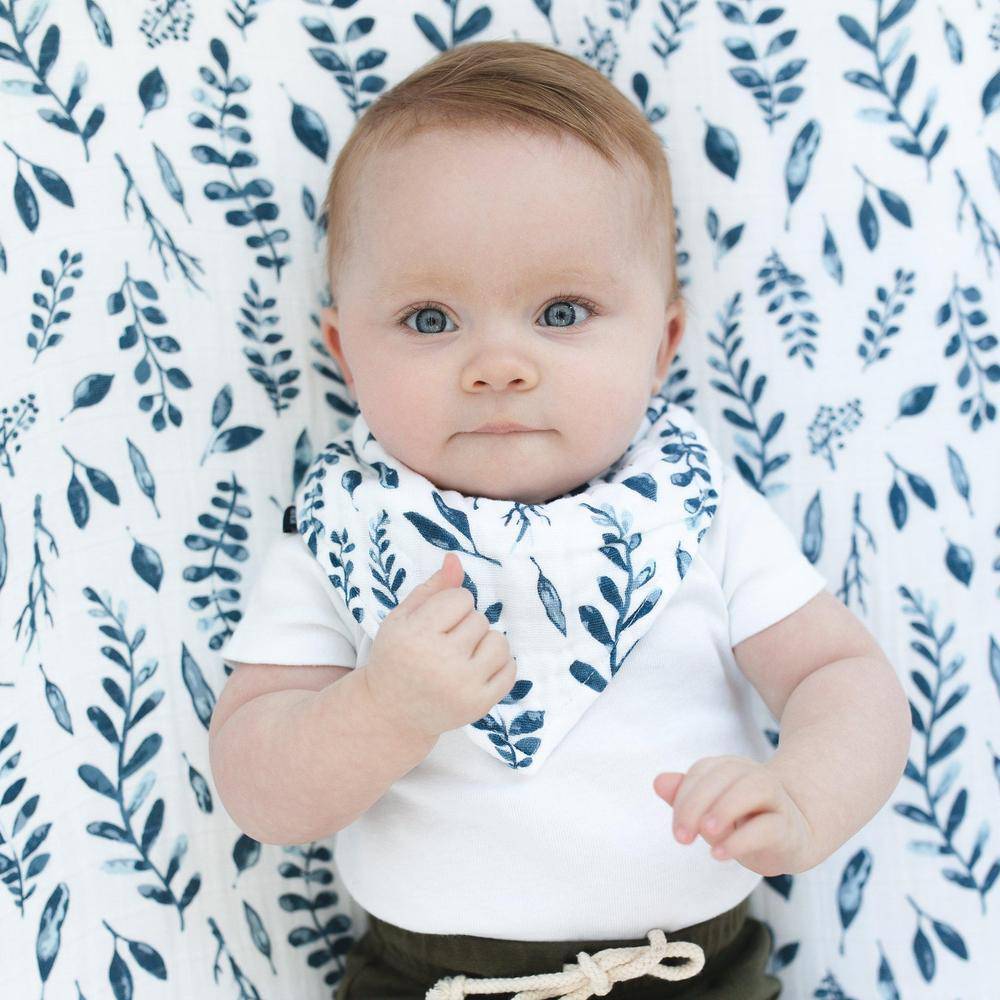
{"left": 733, "top": 590, "right": 911, "bottom": 871}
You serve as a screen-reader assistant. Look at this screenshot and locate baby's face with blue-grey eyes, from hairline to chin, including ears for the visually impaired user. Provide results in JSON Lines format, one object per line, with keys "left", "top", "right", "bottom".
{"left": 322, "top": 129, "right": 684, "bottom": 503}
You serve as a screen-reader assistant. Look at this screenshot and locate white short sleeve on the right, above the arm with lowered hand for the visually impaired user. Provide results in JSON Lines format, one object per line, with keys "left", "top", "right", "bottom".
{"left": 706, "top": 462, "right": 826, "bottom": 646}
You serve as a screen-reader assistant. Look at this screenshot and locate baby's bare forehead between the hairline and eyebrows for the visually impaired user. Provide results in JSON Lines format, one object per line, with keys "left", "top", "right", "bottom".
{"left": 350, "top": 140, "right": 670, "bottom": 285}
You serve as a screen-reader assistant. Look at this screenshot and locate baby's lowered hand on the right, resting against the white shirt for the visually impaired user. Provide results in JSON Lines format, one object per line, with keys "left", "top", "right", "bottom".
{"left": 653, "top": 754, "right": 812, "bottom": 875}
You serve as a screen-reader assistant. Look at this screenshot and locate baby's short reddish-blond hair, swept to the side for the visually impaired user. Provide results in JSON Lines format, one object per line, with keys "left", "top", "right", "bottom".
{"left": 323, "top": 40, "right": 680, "bottom": 302}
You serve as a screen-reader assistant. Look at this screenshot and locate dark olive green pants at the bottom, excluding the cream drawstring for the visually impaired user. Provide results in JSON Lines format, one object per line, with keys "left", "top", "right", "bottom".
{"left": 335, "top": 897, "right": 781, "bottom": 1000}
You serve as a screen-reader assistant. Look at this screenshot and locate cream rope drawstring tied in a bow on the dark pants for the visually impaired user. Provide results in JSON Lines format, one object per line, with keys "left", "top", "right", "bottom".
{"left": 424, "top": 928, "right": 705, "bottom": 1000}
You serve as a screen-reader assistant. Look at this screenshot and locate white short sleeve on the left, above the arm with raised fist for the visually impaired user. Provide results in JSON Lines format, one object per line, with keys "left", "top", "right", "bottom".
{"left": 223, "top": 534, "right": 357, "bottom": 667}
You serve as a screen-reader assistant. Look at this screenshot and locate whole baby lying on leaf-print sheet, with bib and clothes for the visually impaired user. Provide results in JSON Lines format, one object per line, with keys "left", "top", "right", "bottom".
{"left": 210, "top": 41, "right": 910, "bottom": 1000}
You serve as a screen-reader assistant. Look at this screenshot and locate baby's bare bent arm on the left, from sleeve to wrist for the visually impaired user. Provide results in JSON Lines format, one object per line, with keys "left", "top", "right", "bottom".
{"left": 209, "top": 663, "right": 437, "bottom": 844}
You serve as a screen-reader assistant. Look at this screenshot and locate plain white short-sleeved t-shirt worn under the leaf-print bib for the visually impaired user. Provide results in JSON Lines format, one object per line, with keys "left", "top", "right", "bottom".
{"left": 225, "top": 461, "right": 826, "bottom": 941}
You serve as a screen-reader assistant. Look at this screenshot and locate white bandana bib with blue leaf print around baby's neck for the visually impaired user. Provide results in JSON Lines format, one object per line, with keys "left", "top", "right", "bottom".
{"left": 284, "top": 394, "right": 722, "bottom": 774}
